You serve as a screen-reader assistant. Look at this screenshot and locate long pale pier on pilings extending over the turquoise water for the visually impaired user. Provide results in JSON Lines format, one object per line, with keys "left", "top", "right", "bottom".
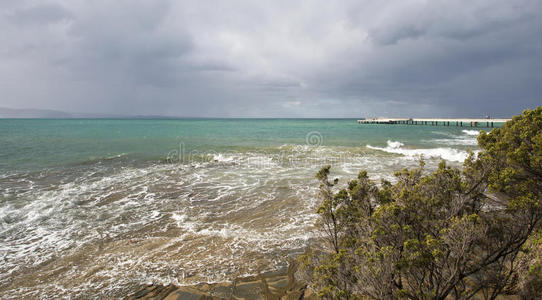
{"left": 358, "top": 118, "right": 510, "bottom": 128}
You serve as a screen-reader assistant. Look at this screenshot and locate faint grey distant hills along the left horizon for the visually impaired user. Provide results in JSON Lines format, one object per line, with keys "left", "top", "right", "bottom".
{"left": 0, "top": 107, "right": 176, "bottom": 119}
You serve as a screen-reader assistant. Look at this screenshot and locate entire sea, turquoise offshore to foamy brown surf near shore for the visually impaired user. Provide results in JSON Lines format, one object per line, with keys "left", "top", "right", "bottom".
{"left": 0, "top": 119, "right": 500, "bottom": 299}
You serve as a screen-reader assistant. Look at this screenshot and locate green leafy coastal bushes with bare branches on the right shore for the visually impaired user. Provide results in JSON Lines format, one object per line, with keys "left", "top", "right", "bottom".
{"left": 301, "top": 107, "right": 542, "bottom": 299}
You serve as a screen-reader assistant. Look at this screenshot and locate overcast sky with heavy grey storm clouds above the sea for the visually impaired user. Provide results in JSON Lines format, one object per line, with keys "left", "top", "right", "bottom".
{"left": 0, "top": 0, "right": 542, "bottom": 117}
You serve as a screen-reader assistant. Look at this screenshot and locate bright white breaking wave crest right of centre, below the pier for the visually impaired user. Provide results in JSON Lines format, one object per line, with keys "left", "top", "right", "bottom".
{"left": 367, "top": 141, "right": 474, "bottom": 162}
